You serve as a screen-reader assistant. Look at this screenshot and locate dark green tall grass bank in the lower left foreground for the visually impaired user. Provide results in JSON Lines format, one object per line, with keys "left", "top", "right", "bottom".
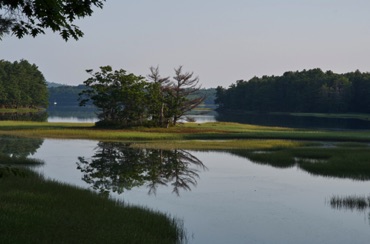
{"left": 0, "top": 168, "right": 185, "bottom": 244}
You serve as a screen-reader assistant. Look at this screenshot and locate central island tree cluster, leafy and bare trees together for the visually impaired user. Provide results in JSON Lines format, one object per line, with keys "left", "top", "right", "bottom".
{"left": 80, "top": 66, "right": 204, "bottom": 127}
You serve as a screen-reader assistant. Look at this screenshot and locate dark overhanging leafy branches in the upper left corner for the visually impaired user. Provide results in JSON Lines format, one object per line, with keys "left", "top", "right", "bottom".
{"left": 0, "top": 0, "right": 105, "bottom": 41}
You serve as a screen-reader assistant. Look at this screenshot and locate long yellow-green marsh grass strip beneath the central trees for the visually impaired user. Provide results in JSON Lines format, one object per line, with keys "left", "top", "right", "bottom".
{"left": 0, "top": 121, "right": 370, "bottom": 145}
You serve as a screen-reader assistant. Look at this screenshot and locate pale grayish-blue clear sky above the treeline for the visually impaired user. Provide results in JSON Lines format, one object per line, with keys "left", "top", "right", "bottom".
{"left": 0, "top": 0, "right": 370, "bottom": 88}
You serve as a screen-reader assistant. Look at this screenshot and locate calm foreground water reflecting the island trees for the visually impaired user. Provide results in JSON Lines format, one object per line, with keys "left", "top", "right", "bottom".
{"left": 10, "top": 139, "right": 370, "bottom": 244}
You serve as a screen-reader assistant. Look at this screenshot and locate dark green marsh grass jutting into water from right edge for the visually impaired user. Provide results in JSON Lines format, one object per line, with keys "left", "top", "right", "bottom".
{"left": 230, "top": 145, "right": 370, "bottom": 180}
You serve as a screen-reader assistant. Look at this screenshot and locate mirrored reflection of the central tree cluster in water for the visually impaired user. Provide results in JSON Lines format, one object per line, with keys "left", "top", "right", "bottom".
{"left": 77, "top": 142, "right": 206, "bottom": 195}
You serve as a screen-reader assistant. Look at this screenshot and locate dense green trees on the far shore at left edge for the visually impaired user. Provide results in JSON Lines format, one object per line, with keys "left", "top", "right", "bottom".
{"left": 0, "top": 60, "right": 48, "bottom": 108}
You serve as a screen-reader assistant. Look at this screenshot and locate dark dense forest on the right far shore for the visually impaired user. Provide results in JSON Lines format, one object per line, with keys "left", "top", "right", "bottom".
{"left": 215, "top": 69, "right": 370, "bottom": 113}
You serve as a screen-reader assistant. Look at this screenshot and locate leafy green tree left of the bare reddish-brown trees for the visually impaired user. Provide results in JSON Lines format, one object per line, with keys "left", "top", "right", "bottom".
{"left": 80, "top": 66, "right": 148, "bottom": 126}
